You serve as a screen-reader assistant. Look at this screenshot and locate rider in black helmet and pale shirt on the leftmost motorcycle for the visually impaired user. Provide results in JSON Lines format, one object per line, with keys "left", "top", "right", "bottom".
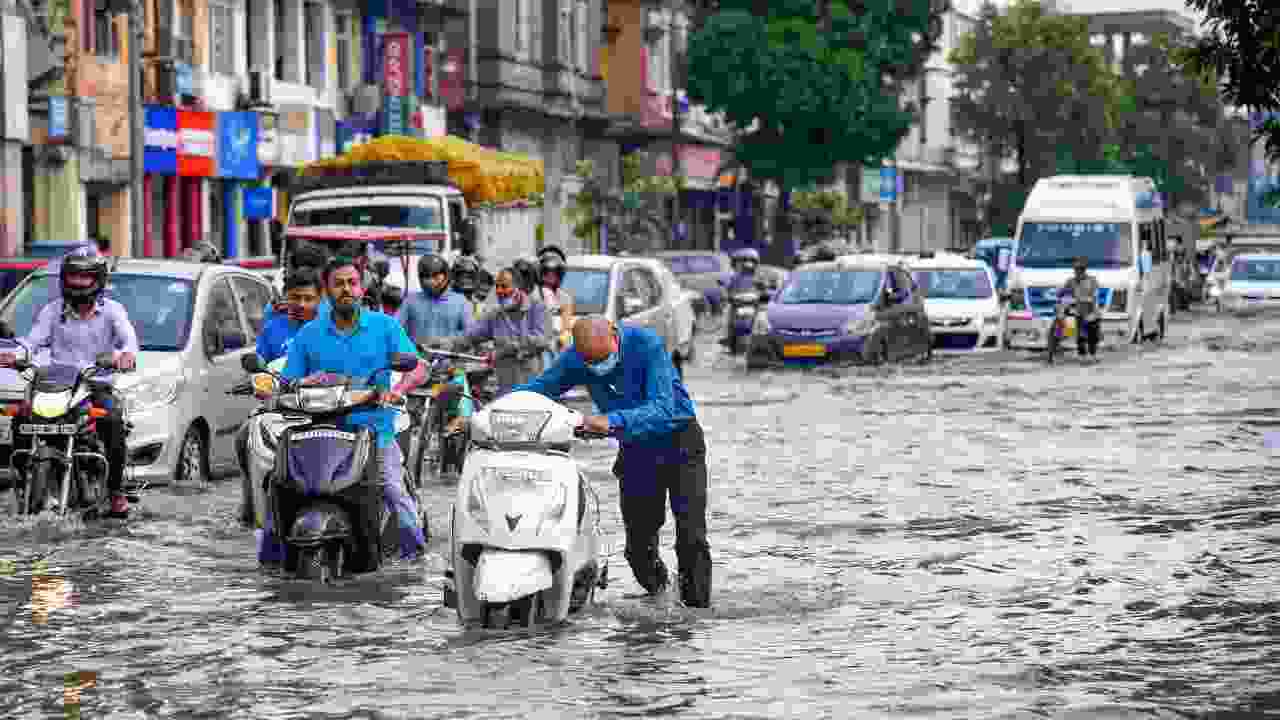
{"left": 0, "top": 250, "right": 138, "bottom": 518}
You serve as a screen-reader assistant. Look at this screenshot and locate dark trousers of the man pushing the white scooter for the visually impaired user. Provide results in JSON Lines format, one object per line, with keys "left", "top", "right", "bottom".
{"left": 613, "top": 420, "right": 712, "bottom": 607}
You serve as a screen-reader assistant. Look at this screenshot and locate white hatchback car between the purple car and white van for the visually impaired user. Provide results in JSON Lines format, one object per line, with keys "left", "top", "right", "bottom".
{"left": 908, "top": 252, "right": 1005, "bottom": 352}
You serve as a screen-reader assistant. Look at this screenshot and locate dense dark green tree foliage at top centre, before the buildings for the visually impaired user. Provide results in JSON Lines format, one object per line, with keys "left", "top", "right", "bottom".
{"left": 687, "top": 0, "right": 941, "bottom": 188}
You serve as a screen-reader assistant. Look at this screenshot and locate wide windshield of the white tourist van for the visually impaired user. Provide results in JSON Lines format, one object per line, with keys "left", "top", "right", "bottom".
{"left": 1018, "top": 222, "right": 1133, "bottom": 269}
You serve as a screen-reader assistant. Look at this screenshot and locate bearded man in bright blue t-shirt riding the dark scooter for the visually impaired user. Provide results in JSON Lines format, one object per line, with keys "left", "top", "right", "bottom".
{"left": 259, "top": 256, "right": 426, "bottom": 560}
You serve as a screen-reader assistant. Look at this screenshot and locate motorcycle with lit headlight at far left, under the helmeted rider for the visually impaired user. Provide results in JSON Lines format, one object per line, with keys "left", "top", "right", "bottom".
{"left": 0, "top": 341, "right": 131, "bottom": 519}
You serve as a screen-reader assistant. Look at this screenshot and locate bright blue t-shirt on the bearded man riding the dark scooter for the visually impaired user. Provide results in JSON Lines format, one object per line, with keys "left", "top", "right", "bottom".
{"left": 282, "top": 307, "right": 417, "bottom": 447}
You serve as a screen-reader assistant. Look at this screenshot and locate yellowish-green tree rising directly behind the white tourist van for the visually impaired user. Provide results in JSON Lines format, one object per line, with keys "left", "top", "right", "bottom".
{"left": 948, "top": 0, "right": 1120, "bottom": 227}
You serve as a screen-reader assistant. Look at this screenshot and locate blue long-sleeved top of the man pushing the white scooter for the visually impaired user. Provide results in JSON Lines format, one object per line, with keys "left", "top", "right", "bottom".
{"left": 513, "top": 327, "right": 696, "bottom": 448}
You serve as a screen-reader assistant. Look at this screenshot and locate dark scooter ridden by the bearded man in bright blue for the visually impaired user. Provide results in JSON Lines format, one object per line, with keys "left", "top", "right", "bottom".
{"left": 242, "top": 354, "right": 417, "bottom": 582}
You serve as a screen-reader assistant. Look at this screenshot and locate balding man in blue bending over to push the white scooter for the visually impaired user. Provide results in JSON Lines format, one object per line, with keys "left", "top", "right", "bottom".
{"left": 515, "top": 316, "right": 712, "bottom": 607}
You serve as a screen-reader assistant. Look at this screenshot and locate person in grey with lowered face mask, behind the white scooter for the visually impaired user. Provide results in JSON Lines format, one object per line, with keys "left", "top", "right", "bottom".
{"left": 452, "top": 268, "right": 550, "bottom": 395}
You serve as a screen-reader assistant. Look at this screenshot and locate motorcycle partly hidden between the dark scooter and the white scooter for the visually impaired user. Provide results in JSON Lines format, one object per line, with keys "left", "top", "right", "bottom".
{"left": 404, "top": 347, "right": 493, "bottom": 488}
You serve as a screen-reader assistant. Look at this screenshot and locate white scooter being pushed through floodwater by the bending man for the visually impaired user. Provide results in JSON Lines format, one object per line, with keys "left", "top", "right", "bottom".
{"left": 444, "top": 392, "right": 608, "bottom": 628}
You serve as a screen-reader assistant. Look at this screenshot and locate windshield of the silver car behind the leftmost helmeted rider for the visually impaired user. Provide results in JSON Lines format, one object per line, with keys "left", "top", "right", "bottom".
{"left": 0, "top": 273, "right": 195, "bottom": 352}
